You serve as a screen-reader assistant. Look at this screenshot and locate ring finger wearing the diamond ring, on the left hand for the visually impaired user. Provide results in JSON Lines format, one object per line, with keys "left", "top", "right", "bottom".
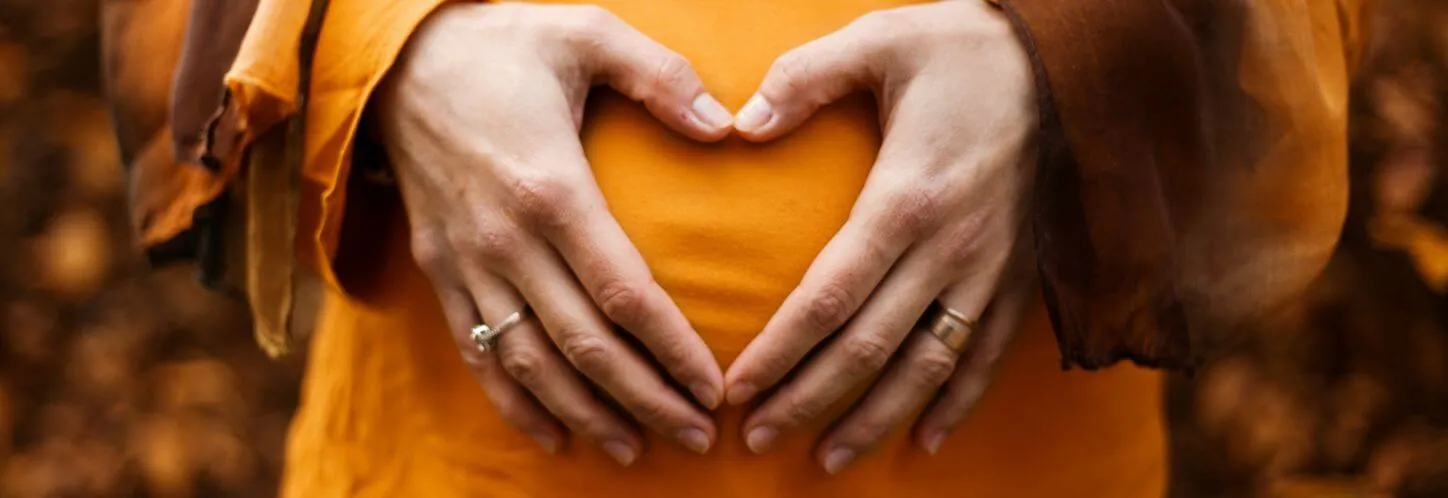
{"left": 471, "top": 270, "right": 643, "bottom": 466}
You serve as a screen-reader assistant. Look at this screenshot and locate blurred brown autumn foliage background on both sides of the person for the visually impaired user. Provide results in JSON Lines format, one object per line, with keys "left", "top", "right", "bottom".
{"left": 0, "top": 0, "right": 1448, "bottom": 498}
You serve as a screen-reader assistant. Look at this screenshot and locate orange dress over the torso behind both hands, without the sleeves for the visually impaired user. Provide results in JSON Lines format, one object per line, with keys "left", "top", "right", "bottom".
{"left": 284, "top": 0, "right": 1164, "bottom": 498}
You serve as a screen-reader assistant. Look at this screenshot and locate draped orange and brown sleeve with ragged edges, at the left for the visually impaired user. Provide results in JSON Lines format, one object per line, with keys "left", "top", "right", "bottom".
{"left": 130, "top": 0, "right": 445, "bottom": 356}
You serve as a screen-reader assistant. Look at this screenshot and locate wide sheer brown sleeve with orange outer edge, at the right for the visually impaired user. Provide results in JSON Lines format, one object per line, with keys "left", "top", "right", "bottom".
{"left": 998, "top": 0, "right": 1364, "bottom": 369}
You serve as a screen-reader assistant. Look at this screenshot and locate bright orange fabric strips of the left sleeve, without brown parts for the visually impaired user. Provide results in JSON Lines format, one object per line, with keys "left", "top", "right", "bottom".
{"left": 221, "top": 0, "right": 447, "bottom": 285}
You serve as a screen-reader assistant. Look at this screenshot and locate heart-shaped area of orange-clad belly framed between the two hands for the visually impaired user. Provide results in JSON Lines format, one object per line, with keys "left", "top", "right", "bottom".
{"left": 585, "top": 96, "right": 879, "bottom": 356}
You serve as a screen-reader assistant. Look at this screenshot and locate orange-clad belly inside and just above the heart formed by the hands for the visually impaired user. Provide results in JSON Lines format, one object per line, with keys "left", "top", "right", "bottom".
{"left": 570, "top": 0, "right": 909, "bottom": 360}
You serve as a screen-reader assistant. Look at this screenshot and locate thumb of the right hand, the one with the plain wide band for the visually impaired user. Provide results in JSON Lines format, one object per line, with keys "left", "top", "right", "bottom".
{"left": 734, "top": 19, "right": 880, "bottom": 142}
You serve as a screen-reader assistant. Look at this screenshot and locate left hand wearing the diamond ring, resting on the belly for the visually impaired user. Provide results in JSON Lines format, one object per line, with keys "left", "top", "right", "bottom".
{"left": 376, "top": 3, "right": 733, "bottom": 465}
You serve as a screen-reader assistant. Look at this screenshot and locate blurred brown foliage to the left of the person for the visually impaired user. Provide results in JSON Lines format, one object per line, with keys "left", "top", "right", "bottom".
{"left": 0, "top": 0, "right": 300, "bottom": 498}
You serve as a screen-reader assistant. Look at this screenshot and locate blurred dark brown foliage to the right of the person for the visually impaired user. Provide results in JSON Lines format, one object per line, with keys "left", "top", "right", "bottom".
{"left": 1167, "top": 0, "right": 1448, "bottom": 498}
